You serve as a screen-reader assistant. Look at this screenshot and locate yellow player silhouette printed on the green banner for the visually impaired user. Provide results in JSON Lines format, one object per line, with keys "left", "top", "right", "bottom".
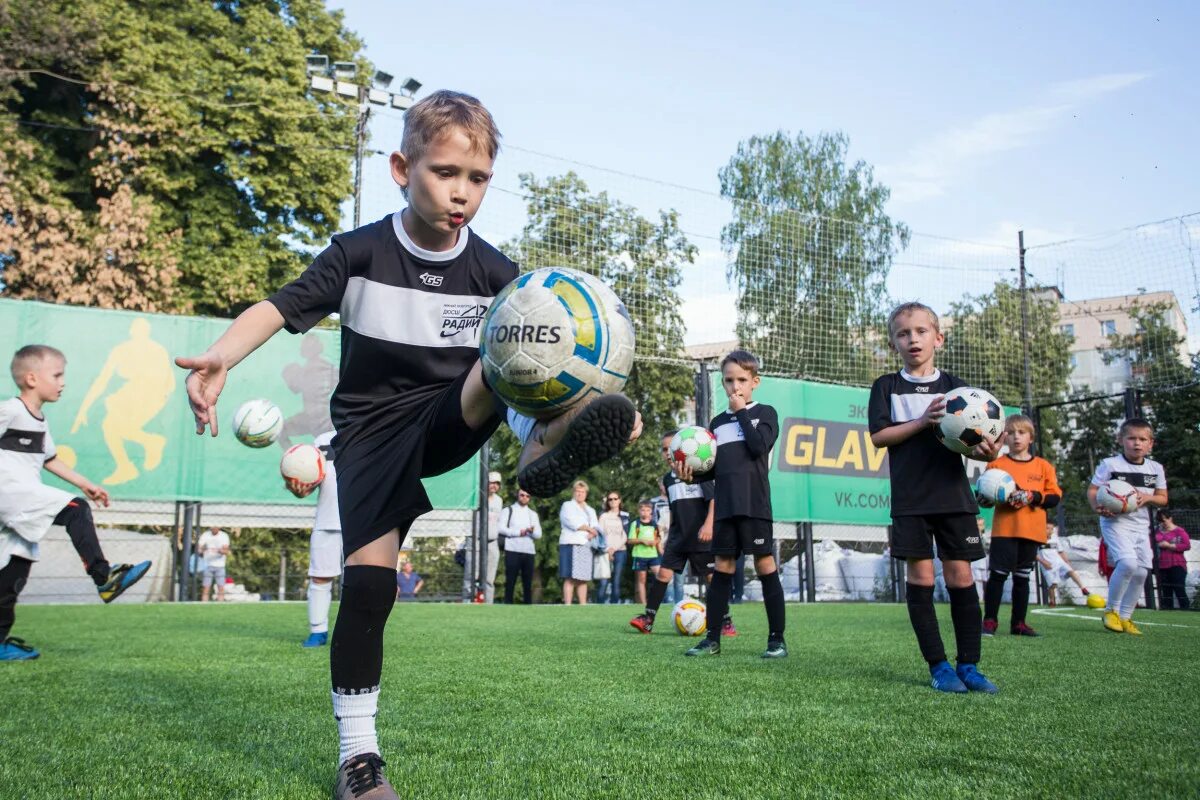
{"left": 71, "top": 319, "right": 175, "bottom": 486}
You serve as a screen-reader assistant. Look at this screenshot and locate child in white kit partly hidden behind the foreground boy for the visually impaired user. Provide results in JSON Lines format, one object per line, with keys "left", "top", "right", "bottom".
{"left": 283, "top": 431, "right": 342, "bottom": 648}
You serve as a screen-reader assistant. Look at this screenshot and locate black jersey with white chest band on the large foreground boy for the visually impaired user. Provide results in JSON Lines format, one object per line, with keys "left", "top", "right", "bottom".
{"left": 269, "top": 212, "right": 517, "bottom": 433}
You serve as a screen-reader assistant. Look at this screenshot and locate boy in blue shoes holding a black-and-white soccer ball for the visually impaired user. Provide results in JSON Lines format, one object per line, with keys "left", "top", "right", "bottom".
{"left": 866, "top": 302, "right": 1000, "bottom": 693}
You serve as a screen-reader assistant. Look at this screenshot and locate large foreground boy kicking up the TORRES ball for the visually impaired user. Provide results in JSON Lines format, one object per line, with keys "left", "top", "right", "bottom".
{"left": 175, "top": 91, "right": 641, "bottom": 799}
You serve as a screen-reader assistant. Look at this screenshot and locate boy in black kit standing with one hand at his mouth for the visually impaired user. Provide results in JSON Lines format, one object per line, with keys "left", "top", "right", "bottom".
{"left": 673, "top": 350, "right": 787, "bottom": 658}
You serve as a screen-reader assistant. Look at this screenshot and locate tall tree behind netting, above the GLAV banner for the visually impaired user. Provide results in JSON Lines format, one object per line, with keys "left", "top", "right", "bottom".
{"left": 719, "top": 131, "right": 908, "bottom": 384}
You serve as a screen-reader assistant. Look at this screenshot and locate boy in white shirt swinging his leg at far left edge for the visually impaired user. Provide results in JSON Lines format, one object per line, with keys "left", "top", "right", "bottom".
{"left": 0, "top": 344, "right": 150, "bottom": 661}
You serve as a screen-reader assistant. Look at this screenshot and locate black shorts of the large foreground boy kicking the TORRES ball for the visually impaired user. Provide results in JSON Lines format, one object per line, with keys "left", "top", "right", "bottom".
{"left": 332, "top": 371, "right": 500, "bottom": 555}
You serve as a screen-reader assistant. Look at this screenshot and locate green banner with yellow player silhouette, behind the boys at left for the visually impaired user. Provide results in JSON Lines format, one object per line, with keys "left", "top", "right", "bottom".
{"left": 0, "top": 300, "right": 479, "bottom": 509}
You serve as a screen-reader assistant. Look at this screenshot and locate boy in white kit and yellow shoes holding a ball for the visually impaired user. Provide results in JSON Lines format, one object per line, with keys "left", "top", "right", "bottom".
{"left": 1087, "top": 417, "right": 1166, "bottom": 636}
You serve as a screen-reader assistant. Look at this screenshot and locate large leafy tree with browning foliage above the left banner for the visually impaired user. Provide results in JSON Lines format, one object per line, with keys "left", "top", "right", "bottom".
{"left": 0, "top": 0, "right": 366, "bottom": 315}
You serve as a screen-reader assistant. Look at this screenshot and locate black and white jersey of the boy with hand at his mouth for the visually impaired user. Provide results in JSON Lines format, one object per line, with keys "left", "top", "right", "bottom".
{"left": 695, "top": 403, "right": 779, "bottom": 519}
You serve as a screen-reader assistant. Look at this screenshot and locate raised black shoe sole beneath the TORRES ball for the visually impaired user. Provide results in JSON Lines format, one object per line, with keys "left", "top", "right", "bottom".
{"left": 517, "top": 395, "right": 637, "bottom": 498}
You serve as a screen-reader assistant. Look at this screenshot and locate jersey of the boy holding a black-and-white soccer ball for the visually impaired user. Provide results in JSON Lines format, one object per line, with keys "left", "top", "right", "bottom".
{"left": 866, "top": 369, "right": 979, "bottom": 517}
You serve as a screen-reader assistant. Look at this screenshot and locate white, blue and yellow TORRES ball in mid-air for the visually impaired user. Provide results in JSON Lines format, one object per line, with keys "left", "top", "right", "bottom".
{"left": 479, "top": 266, "right": 634, "bottom": 419}
